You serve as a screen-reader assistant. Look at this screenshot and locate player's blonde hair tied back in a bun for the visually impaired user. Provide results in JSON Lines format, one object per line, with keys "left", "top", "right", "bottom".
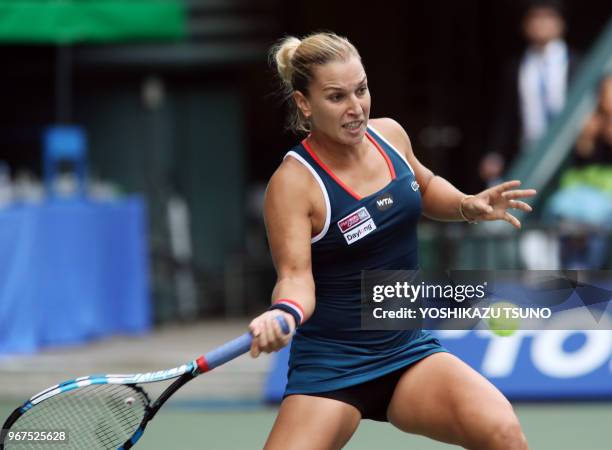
{"left": 270, "top": 32, "right": 361, "bottom": 133}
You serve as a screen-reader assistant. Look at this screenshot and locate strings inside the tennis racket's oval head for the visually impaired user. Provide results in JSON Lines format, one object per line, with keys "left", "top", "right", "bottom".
{"left": 6, "top": 384, "right": 149, "bottom": 450}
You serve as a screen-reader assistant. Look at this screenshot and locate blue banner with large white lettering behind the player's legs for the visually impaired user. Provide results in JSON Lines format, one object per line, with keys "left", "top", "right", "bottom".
{"left": 264, "top": 324, "right": 612, "bottom": 402}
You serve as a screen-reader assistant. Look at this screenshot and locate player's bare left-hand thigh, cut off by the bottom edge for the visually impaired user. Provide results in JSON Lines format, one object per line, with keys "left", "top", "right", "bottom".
{"left": 265, "top": 395, "right": 361, "bottom": 450}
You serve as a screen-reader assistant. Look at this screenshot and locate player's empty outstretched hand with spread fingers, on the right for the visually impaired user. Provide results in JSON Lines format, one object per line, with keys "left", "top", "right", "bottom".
{"left": 462, "top": 180, "right": 536, "bottom": 229}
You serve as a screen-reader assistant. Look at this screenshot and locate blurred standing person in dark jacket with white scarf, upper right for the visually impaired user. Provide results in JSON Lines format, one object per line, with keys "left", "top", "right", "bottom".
{"left": 479, "top": 0, "right": 578, "bottom": 186}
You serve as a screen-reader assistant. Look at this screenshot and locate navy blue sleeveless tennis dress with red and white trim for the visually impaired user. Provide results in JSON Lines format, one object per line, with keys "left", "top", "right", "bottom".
{"left": 285, "top": 126, "right": 446, "bottom": 395}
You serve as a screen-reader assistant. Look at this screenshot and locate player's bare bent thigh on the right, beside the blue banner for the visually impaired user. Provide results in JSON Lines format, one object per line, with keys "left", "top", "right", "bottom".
{"left": 387, "top": 353, "right": 520, "bottom": 448}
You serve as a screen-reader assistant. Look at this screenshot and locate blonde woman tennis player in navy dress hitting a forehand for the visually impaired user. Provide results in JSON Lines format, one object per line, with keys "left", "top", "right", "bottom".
{"left": 250, "top": 33, "right": 535, "bottom": 450}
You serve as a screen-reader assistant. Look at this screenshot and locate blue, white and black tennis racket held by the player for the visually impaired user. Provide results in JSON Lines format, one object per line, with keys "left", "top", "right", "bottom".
{"left": 0, "top": 316, "right": 290, "bottom": 450}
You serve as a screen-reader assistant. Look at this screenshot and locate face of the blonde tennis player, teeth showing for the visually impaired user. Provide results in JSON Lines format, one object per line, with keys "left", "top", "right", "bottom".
{"left": 298, "top": 56, "right": 370, "bottom": 145}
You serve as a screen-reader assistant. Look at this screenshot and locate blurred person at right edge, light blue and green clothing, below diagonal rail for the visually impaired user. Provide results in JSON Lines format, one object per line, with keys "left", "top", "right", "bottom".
{"left": 546, "top": 74, "right": 612, "bottom": 269}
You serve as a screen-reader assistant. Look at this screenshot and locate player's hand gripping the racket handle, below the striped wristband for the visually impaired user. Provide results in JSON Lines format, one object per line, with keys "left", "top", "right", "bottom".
{"left": 249, "top": 309, "right": 295, "bottom": 358}
